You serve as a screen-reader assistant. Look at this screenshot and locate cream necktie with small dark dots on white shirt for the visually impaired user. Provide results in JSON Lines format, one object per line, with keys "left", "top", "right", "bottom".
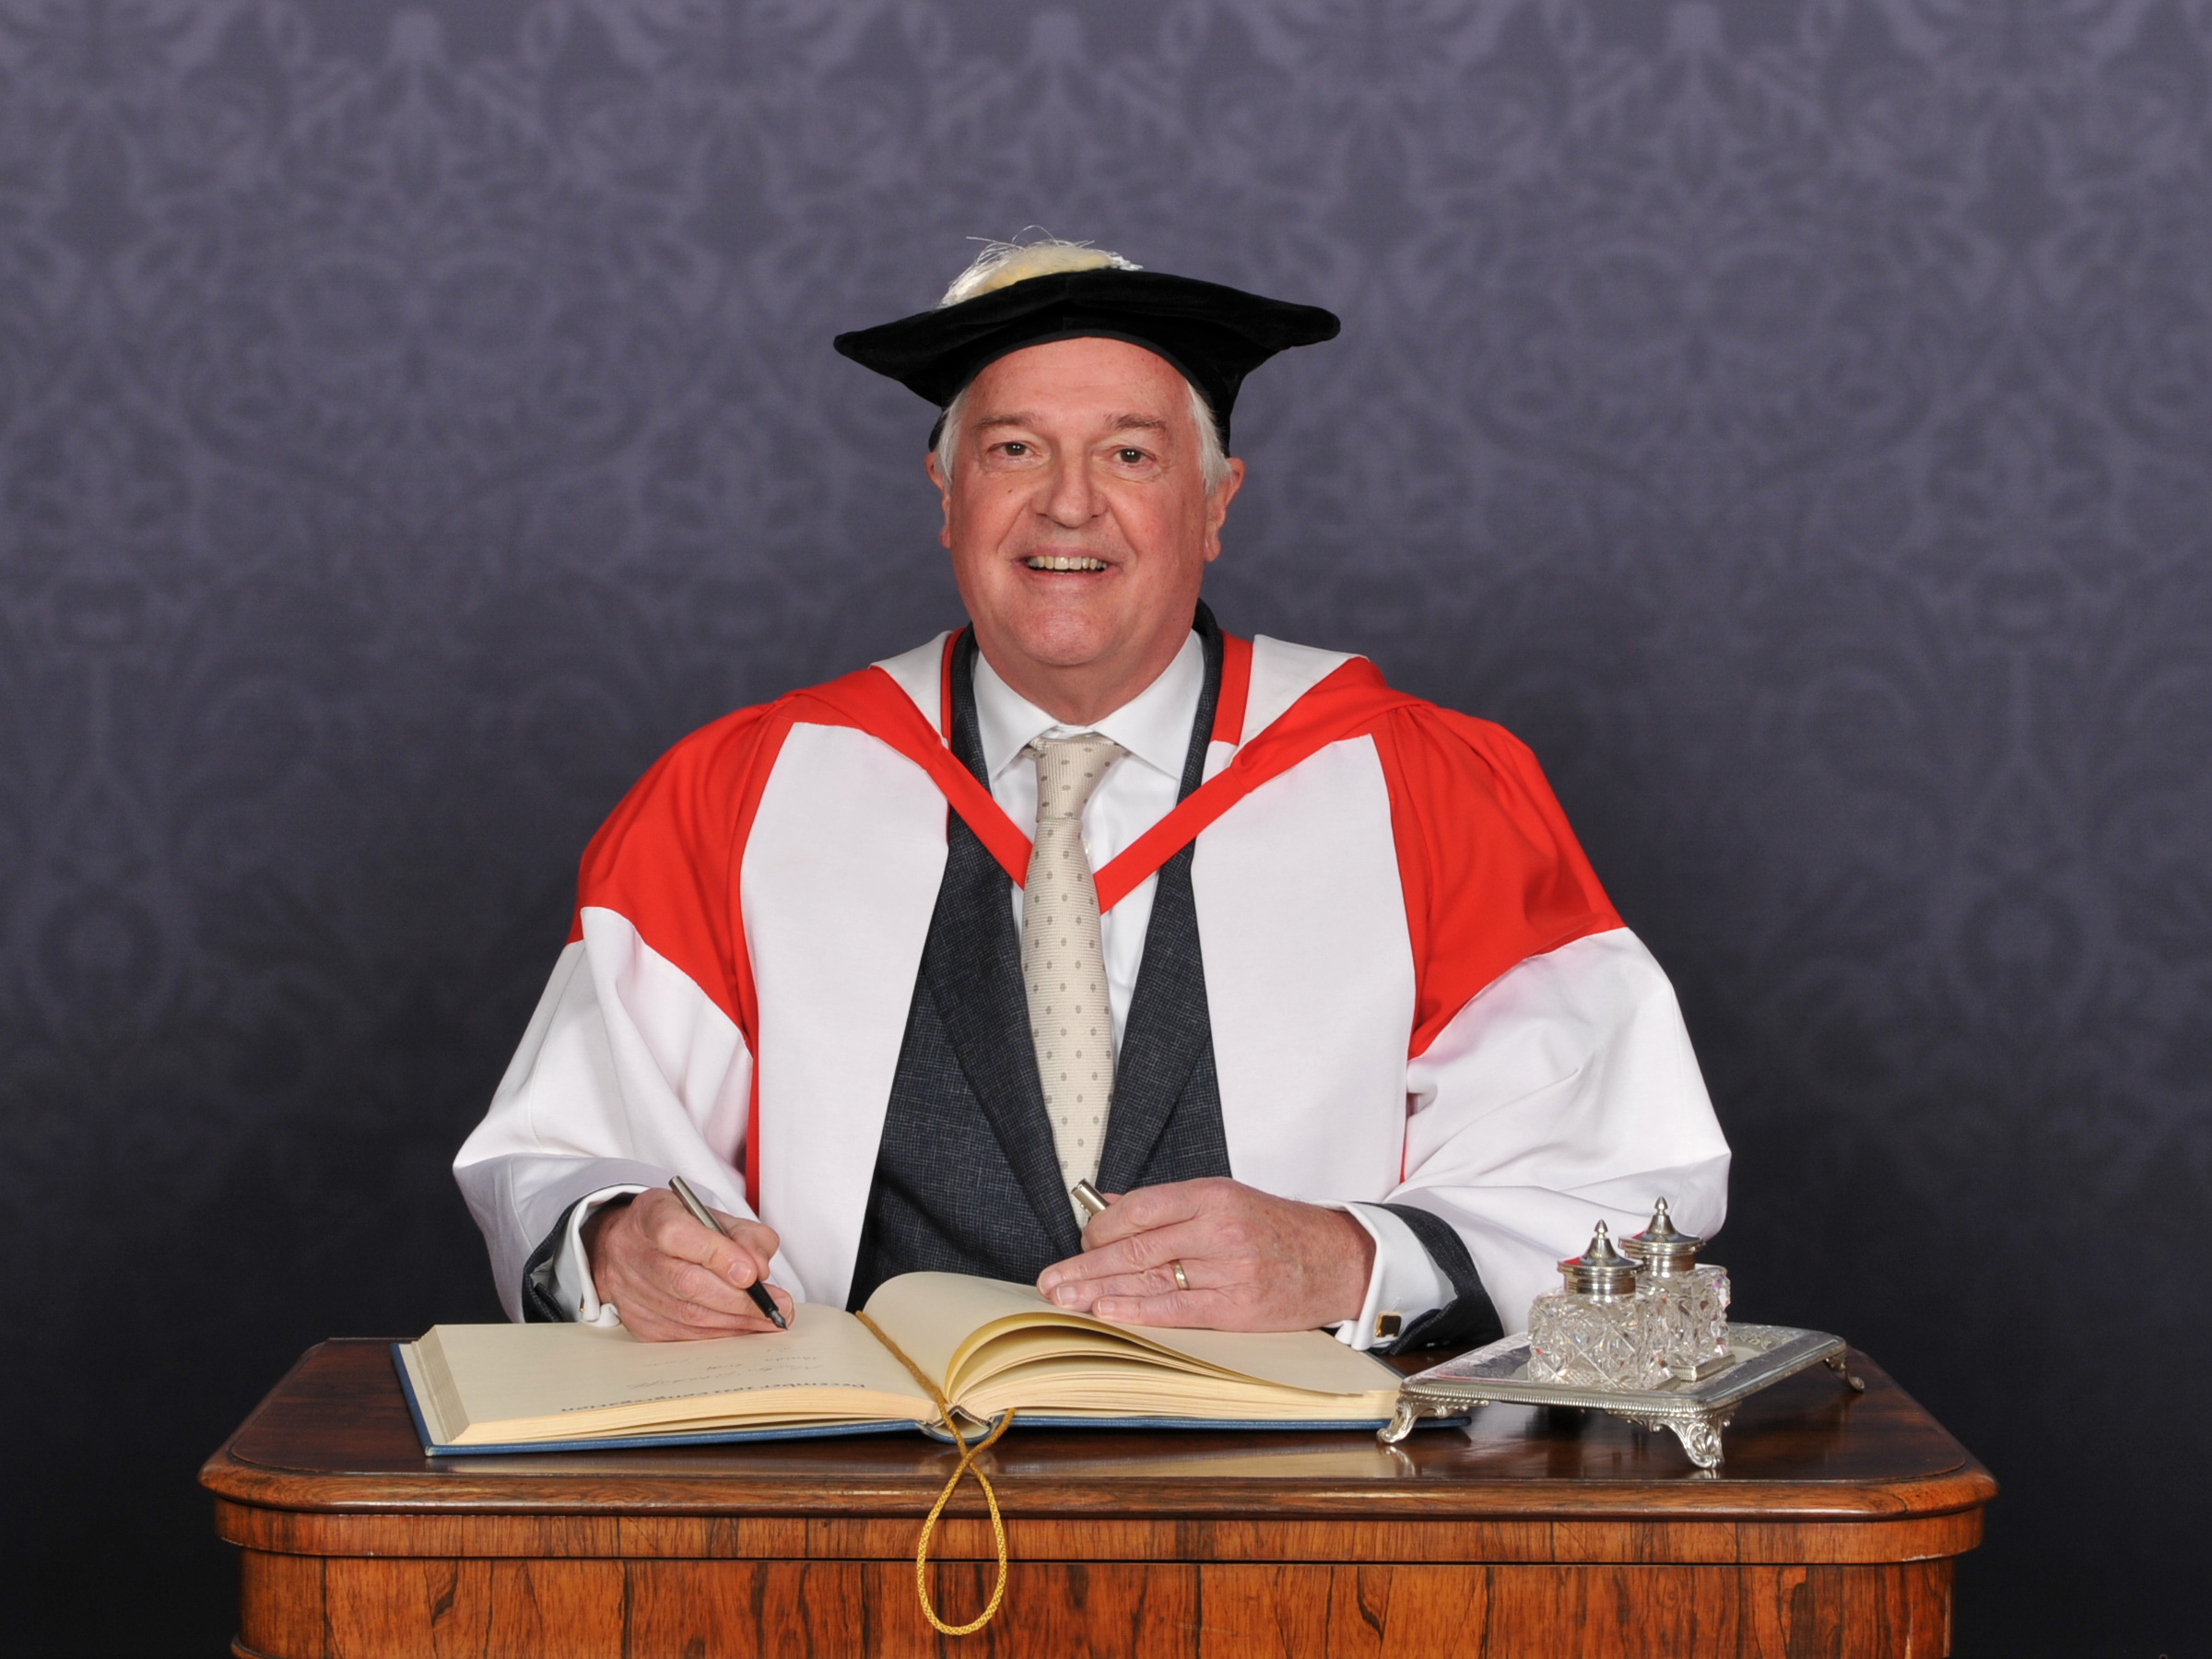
{"left": 1022, "top": 732, "right": 1128, "bottom": 1223}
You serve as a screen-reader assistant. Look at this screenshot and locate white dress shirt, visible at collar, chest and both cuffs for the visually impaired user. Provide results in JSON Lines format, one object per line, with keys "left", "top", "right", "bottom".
{"left": 553, "top": 635, "right": 1451, "bottom": 1347}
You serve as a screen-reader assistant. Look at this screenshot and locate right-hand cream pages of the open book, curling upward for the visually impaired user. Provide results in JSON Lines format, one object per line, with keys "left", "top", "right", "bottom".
{"left": 867, "top": 1274, "right": 1398, "bottom": 1420}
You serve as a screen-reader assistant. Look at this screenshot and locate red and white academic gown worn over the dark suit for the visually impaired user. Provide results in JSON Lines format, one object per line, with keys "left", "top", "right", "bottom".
{"left": 455, "top": 637, "right": 1727, "bottom": 1332}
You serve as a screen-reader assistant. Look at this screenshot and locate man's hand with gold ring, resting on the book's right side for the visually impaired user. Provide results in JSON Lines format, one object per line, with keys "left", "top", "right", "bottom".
{"left": 1038, "top": 1179, "right": 1376, "bottom": 1332}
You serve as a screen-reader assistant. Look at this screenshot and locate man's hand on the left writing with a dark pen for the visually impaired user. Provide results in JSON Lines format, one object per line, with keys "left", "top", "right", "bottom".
{"left": 584, "top": 1193, "right": 792, "bottom": 1343}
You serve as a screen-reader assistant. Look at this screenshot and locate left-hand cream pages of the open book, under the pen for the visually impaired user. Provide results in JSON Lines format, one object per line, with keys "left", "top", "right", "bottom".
{"left": 403, "top": 1303, "right": 935, "bottom": 1447}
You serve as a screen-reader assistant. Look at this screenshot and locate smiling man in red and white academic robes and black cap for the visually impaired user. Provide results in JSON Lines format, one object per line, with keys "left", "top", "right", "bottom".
{"left": 455, "top": 243, "right": 1727, "bottom": 1347}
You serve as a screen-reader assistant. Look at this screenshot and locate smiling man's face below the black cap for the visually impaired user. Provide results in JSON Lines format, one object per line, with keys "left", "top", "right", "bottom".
{"left": 929, "top": 338, "right": 1243, "bottom": 719}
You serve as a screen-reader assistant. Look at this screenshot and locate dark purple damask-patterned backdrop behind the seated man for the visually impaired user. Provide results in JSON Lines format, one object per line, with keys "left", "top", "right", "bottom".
{"left": 0, "top": 0, "right": 2212, "bottom": 1657}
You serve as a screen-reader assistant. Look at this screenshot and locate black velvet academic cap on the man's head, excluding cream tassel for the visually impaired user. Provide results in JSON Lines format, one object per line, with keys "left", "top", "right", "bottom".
{"left": 836, "top": 267, "right": 1340, "bottom": 449}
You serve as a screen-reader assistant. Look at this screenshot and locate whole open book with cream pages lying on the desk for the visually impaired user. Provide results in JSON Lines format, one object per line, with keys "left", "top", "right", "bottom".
{"left": 394, "top": 1274, "right": 1398, "bottom": 1453}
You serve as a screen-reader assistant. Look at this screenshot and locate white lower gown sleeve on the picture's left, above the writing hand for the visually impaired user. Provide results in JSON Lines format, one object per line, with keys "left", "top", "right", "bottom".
{"left": 453, "top": 909, "right": 782, "bottom": 1318}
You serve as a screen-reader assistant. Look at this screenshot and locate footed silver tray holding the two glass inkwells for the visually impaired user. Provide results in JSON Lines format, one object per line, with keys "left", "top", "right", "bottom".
{"left": 1376, "top": 1325, "right": 1867, "bottom": 1471}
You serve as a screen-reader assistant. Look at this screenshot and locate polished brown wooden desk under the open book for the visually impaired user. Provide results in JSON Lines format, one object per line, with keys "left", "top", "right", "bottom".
{"left": 201, "top": 1340, "right": 1995, "bottom": 1659}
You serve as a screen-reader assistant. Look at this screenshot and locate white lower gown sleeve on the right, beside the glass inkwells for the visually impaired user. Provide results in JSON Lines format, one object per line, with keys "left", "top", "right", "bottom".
{"left": 1389, "top": 929, "right": 1727, "bottom": 1332}
